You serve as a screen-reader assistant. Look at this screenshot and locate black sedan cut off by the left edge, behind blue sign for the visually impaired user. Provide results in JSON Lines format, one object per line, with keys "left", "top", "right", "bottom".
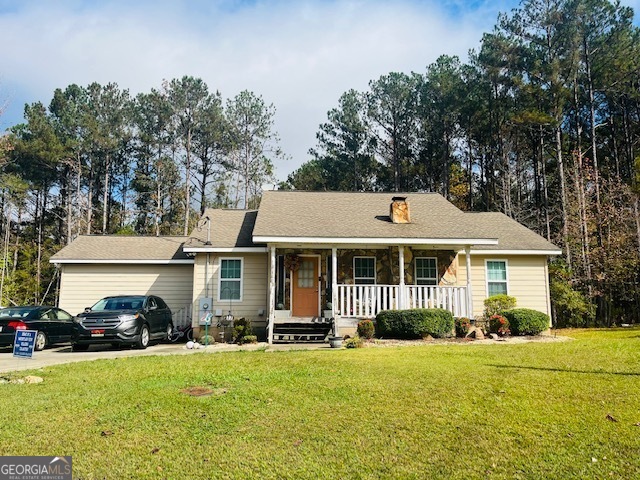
{"left": 0, "top": 306, "right": 73, "bottom": 351}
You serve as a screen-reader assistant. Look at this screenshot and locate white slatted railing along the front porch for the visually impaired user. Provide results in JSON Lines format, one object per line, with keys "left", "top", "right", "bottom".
{"left": 336, "top": 285, "right": 468, "bottom": 318}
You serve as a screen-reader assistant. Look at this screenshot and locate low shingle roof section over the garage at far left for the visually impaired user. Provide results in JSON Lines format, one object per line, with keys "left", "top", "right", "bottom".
{"left": 51, "top": 235, "right": 188, "bottom": 263}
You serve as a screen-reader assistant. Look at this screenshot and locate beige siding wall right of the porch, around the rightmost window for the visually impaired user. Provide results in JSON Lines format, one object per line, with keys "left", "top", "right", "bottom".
{"left": 458, "top": 253, "right": 551, "bottom": 316}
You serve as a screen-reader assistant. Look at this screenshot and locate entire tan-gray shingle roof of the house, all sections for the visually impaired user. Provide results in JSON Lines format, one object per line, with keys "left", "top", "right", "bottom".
{"left": 51, "top": 191, "right": 559, "bottom": 263}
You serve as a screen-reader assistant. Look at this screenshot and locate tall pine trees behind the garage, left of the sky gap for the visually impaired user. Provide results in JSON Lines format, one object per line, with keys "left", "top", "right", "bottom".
{"left": 0, "top": 76, "right": 283, "bottom": 305}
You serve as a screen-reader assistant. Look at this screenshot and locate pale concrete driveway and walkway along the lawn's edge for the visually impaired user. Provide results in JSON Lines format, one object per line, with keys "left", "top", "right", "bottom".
{"left": 0, "top": 343, "right": 330, "bottom": 373}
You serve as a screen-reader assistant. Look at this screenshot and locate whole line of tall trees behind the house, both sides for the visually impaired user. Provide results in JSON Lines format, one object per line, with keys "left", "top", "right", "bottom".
{"left": 0, "top": 0, "right": 640, "bottom": 325}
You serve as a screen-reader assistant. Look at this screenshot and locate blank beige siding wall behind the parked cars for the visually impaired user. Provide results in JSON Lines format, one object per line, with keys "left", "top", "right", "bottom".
{"left": 58, "top": 264, "right": 193, "bottom": 315}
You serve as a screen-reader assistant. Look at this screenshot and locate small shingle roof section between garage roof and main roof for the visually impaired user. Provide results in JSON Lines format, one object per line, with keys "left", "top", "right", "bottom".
{"left": 185, "top": 208, "right": 264, "bottom": 248}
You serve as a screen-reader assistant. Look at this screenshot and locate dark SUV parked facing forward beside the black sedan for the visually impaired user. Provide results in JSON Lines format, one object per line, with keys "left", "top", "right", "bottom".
{"left": 72, "top": 295, "right": 173, "bottom": 351}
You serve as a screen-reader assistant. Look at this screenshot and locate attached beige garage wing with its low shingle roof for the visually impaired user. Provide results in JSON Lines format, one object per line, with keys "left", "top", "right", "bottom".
{"left": 51, "top": 235, "right": 194, "bottom": 315}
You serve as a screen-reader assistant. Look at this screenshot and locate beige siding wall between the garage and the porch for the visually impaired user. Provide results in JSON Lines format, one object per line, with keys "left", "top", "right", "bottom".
{"left": 193, "top": 253, "right": 269, "bottom": 328}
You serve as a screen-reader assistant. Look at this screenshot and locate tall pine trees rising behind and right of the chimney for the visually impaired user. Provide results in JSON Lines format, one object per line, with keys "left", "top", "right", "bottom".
{"left": 282, "top": 0, "right": 640, "bottom": 325}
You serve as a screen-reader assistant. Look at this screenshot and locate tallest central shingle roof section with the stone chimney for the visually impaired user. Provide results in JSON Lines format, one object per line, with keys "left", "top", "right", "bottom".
{"left": 253, "top": 191, "right": 496, "bottom": 240}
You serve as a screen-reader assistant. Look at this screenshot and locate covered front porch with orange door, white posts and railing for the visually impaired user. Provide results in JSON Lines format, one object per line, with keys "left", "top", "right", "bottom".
{"left": 267, "top": 245, "right": 473, "bottom": 343}
